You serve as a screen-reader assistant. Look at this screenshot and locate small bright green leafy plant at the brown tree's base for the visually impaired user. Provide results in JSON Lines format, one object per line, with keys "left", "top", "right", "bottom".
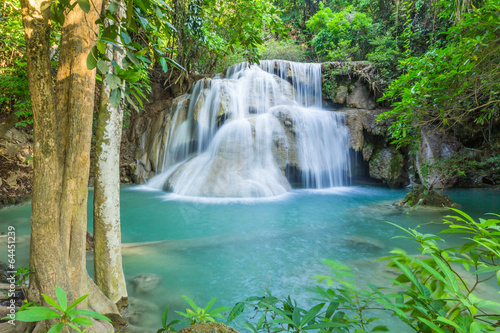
{"left": 9, "top": 286, "right": 111, "bottom": 333}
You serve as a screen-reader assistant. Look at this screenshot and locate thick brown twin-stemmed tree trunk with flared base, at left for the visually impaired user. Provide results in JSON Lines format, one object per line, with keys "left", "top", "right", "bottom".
{"left": 21, "top": 0, "right": 117, "bottom": 332}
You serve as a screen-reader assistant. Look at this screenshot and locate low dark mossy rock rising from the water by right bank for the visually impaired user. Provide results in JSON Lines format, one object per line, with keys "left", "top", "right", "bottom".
{"left": 394, "top": 185, "right": 455, "bottom": 208}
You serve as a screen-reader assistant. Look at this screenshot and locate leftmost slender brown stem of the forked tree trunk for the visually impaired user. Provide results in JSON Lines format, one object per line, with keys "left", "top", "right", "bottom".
{"left": 21, "top": 0, "right": 65, "bottom": 308}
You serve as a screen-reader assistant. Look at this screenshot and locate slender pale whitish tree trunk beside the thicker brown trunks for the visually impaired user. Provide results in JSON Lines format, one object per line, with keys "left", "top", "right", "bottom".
{"left": 94, "top": 1, "right": 128, "bottom": 308}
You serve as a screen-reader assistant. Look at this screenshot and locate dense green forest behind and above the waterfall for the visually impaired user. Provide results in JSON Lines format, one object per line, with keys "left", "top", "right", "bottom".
{"left": 0, "top": 0, "right": 500, "bottom": 155}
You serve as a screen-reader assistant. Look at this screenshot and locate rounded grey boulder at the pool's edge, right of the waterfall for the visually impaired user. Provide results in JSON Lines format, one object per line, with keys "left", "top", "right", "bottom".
{"left": 369, "top": 148, "right": 403, "bottom": 186}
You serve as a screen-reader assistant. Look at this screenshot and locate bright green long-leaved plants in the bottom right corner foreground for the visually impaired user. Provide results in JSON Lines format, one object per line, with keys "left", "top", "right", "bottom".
{"left": 379, "top": 209, "right": 500, "bottom": 333}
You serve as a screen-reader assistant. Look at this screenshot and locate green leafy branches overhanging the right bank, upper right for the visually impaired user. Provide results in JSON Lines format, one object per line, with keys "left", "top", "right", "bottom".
{"left": 381, "top": 0, "right": 500, "bottom": 146}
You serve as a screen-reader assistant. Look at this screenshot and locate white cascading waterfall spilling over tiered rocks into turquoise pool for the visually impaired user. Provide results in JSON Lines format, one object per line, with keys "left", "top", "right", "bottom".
{"left": 148, "top": 60, "right": 349, "bottom": 197}
